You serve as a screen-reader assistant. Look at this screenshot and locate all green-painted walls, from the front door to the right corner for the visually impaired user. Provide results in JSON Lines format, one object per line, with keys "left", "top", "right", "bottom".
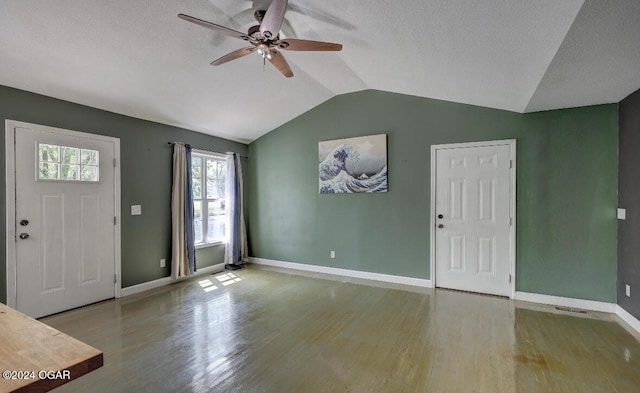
{"left": 0, "top": 86, "right": 617, "bottom": 302}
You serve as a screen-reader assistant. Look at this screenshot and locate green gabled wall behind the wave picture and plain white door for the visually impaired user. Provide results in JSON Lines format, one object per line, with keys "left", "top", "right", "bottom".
{"left": 247, "top": 90, "right": 617, "bottom": 302}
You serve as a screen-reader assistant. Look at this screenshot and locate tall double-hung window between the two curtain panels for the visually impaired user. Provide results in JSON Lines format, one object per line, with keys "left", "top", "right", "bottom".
{"left": 191, "top": 152, "right": 227, "bottom": 246}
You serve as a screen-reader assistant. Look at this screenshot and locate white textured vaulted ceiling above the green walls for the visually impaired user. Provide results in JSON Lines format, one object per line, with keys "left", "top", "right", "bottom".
{"left": 0, "top": 0, "right": 640, "bottom": 142}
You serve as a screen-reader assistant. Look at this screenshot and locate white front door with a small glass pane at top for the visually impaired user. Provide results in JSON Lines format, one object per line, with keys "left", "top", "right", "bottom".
{"left": 7, "top": 126, "right": 116, "bottom": 318}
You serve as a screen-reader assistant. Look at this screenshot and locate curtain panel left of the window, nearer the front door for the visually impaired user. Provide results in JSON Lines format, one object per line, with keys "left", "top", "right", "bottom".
{"left": 171, "top": 142, "right": 196, "bottom": 278}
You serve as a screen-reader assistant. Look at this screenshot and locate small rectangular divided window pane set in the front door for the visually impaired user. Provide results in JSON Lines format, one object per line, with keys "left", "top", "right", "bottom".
{"left": 38, "top": 143, "right": 100, "bottom": 182}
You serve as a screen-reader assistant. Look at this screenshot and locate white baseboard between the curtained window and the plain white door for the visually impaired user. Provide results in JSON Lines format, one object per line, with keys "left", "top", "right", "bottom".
{"left": 247, "top": 257, "right": 433, "bottom": 288}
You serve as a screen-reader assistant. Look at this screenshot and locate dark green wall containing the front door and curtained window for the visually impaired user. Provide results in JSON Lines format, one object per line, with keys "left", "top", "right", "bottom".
{"left": 0, "top": 86, "right": 247, "bottom": 302}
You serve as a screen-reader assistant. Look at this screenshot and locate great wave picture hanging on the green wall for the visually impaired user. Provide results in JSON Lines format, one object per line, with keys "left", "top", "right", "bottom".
{"left": 318, "top": 134, "right": 387, "bottom": 194}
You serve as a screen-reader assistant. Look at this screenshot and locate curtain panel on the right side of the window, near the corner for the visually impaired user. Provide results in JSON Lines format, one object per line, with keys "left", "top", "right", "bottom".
{"left": 225, "top": 153, "right": 248, "bottom": 265}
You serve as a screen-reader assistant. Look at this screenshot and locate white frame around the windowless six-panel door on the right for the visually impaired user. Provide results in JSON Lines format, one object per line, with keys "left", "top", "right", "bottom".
{"left": 429, "top": 139, "right": 516, "bottom": 299}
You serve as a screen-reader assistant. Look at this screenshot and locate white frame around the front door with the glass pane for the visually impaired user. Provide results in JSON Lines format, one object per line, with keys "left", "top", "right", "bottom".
{"left": 5, "top": 119, "right": 122, "bottom": 308}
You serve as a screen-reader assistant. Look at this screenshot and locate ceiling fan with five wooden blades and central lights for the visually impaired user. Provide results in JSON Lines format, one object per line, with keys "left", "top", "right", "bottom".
{"left": 178, "top": 0, "right": 342, "bottom": 78}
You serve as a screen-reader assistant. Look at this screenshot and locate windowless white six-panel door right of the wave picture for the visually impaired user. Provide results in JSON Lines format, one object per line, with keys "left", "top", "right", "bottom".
{"left": 434, "top": 142, "right": 515, "bottom": 296}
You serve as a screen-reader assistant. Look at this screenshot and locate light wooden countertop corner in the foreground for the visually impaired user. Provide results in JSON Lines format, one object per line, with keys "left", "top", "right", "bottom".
{"left": 0, "top": 303, "right": 103, "bottom": 392}
